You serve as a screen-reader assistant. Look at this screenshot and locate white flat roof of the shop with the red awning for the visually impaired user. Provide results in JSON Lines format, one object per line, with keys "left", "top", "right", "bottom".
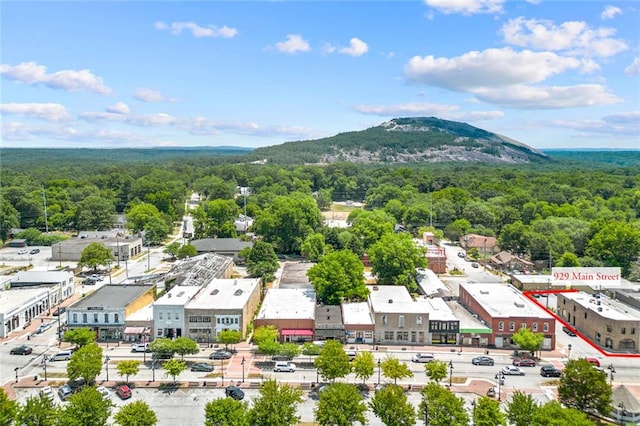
{"left": 256, "top": 288, "right": 316, "bottom": 319}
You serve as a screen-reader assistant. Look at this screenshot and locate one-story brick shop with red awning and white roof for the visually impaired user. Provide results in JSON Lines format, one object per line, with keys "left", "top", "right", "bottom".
{"left": 253, "top": 288, "right": 316, "bottom": 343}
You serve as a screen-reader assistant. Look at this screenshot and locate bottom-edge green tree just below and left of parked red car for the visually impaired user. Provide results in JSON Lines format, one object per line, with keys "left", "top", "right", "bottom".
{"left": 58, "top": 386, "right": 113, "bottom": 426}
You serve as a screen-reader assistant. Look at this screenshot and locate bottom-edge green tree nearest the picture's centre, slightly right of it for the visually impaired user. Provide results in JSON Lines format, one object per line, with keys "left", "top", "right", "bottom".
{"left": 315, "top": 383, "right": 367, "bottom": 426}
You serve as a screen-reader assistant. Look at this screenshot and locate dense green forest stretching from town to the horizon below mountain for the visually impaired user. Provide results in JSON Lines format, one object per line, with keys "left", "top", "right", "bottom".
{"left": 0, "top": 148, "right": 640, "bottom": 280}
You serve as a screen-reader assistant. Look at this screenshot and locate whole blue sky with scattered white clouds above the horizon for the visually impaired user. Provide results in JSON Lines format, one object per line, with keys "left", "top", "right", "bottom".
{"left": 0, "top": 0, "right": 640, "bottom": 149}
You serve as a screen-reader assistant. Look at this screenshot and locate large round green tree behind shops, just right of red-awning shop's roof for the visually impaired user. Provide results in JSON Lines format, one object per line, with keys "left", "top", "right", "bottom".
{"left": 307, "top": 250, "right": 369, "bottom": 305}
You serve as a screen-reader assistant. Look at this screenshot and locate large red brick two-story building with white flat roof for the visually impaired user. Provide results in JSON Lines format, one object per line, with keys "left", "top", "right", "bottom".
{"left": 459, "top": 283, "right": 556, "bottom": 350}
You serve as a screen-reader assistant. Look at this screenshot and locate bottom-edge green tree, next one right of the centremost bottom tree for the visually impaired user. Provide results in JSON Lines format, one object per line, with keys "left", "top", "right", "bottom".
{"left": 369, "top": 385, "right": 416, "bottom": 426}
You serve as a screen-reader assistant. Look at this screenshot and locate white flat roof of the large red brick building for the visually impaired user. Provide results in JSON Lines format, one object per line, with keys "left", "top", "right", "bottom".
{"left": 460, "top": 283, "right": 553, "bottom": 320}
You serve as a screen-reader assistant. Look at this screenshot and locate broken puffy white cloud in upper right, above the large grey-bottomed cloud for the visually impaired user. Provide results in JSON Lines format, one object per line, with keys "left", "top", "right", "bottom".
{"left": 500, "top": 17, "right": 628, "bottom": 57}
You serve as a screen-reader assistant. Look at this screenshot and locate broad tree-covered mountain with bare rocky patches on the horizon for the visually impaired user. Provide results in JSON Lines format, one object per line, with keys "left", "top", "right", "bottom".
{"left": 247, "top": 117, "right": 551, "bottom": 164}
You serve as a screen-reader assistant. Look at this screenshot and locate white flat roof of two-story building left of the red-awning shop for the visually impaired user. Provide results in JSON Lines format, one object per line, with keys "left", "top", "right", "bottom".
{"left": 186, "top": 278, "right": 260, "bottom": 309}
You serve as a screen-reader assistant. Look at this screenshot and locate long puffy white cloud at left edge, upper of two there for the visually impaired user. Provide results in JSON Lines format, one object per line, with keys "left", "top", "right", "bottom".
{"left": 0, "top": 62, "right": 112, "bottom": 95}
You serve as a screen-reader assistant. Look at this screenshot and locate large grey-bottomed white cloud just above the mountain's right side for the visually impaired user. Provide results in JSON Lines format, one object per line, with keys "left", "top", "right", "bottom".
{"left": 404, "top": 48, "right": 582, "bottom": 92}
